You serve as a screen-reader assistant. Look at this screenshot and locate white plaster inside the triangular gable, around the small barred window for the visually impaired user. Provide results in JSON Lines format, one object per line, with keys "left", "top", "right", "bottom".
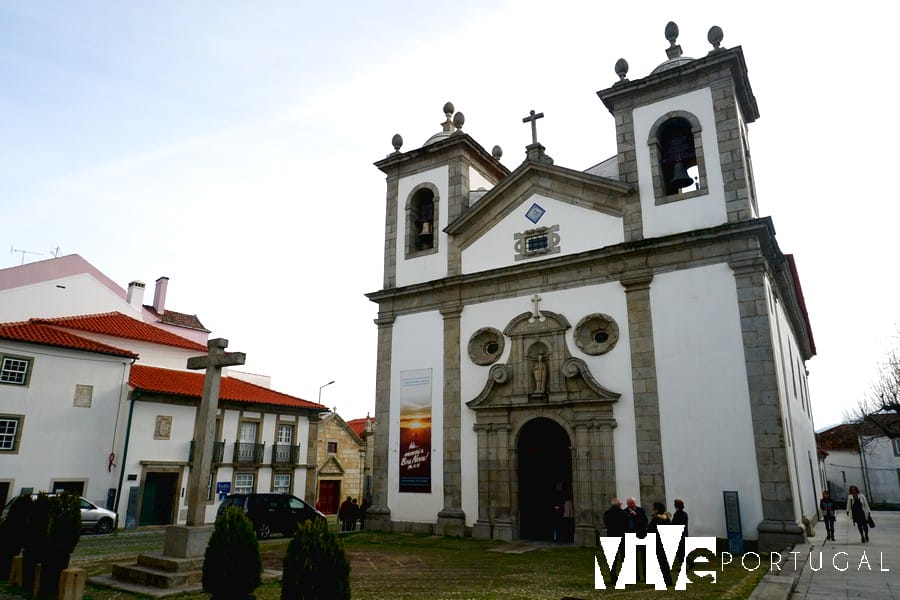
{"left": 462, "top": 194, "right": 625, "bottom": 276}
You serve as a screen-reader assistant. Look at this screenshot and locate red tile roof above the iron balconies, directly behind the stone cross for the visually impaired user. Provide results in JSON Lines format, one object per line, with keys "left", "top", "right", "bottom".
{"left": 128, "top": 365, "right": 328, "bottom": 410}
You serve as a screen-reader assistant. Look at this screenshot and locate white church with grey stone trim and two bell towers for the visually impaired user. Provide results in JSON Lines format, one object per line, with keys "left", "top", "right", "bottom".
{"left": 367, "top": 23, "right": 822, "bottom": 548}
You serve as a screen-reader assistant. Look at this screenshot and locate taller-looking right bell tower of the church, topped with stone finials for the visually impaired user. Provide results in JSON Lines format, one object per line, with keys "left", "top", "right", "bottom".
{"left": 597, "top": 22, "right": 759, "bottom": 241}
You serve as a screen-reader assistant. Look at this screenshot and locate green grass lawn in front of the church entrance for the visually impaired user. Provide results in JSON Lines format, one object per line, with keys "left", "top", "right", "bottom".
{"left": 0, "top": 532, "right": 764, "bottom": 600}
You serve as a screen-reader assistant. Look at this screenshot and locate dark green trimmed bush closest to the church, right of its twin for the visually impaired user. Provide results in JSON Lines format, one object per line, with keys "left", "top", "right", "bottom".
{"left": 281, "top": 520, "right": 350, "bottom": 600}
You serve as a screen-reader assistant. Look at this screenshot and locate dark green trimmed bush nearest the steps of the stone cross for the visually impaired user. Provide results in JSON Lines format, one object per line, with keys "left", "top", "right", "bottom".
{"left": 203, "top": 506, "right": 262, "bottom": 600}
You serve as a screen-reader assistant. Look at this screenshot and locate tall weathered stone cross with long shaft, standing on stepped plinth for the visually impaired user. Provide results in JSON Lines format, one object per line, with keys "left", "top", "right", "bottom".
{"left": 187, "top": 338, "right": 247, "bottom": 526}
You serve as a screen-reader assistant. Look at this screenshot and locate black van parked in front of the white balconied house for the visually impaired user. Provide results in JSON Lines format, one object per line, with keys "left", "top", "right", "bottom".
{"left": 216, "top": 494, "right": 325, "bottom": 540}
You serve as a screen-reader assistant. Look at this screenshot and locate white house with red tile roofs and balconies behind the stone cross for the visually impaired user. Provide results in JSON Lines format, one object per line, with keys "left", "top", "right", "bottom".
{"left": 0, "top": 255, "right": 325, "bottom": 526}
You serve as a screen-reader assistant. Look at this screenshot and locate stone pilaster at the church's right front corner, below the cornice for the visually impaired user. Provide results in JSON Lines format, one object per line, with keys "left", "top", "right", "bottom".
{"left": 730, "top": 257, "right": 806, "bottom": 550}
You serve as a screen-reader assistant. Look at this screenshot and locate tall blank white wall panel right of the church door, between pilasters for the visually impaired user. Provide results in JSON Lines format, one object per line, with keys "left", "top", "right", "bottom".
{"left": 642, "top": 264, "right": 762, "bottom": 539}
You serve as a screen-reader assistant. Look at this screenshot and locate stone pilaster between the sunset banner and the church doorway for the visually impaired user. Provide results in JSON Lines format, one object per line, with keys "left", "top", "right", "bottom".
{"left": 435, "top": 306, "right": 466, "bottom": 536}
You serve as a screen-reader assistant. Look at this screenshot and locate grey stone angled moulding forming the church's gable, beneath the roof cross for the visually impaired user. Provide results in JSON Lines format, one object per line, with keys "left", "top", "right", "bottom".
{"left": 445, "top": 161, "right": 634, "bottom": 249}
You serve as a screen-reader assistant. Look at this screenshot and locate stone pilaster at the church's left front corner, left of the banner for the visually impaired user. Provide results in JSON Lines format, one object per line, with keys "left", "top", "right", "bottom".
{"left": 366, "top": 315, "right": 394, "bottom": 531}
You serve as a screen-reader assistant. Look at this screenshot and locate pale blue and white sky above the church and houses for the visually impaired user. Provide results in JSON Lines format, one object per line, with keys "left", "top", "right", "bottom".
{"left": 0, "top": 0, "right": 900, "bottom": 430}
